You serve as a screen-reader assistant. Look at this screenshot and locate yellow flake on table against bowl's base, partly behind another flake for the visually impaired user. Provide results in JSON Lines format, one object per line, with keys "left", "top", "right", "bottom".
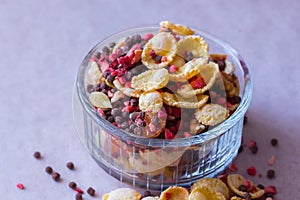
{"left": 191, "top": 178, "right": 229, "bottom": 199}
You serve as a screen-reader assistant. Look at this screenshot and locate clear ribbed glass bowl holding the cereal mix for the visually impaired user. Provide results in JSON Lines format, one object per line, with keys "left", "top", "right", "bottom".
{"left": 73, "top": 27, "right": 252, "bottom": 191}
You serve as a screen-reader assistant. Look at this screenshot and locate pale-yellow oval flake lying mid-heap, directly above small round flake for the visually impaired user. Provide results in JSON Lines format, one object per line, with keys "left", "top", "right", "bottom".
{"left": 131, "top": 69, "right": 169, "bottom": 92}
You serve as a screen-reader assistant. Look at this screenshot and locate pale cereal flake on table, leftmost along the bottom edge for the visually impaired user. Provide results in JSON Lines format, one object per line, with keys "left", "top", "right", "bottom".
{"left": 102, "top": 188, "right": 142, "bottom": 200}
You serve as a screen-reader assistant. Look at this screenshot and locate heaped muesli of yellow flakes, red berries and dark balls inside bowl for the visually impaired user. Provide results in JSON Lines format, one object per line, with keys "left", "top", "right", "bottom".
{"left": 86, "top": 21, "right": 241, "bottom": 139}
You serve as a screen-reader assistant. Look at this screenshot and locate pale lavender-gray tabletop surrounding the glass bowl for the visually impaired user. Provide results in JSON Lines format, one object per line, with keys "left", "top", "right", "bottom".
{"left": 0, "top": 0, "right": 300, "bottom": 200}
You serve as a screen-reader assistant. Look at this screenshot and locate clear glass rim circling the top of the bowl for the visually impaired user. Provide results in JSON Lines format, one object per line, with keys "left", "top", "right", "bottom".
{"left": 75, "top": 26, "right": 253, "bottom": 147}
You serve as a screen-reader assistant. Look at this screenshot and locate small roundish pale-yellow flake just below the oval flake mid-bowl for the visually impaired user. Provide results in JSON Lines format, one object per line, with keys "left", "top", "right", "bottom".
{"left": 139, "top": 91, "right": 163, "bottom": 113}
